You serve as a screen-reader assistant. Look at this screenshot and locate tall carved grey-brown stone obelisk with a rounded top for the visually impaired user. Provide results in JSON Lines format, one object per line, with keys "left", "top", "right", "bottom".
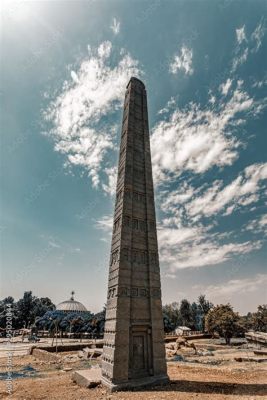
{"left": 102, "top": 78, "right": 168, "bottom": 390}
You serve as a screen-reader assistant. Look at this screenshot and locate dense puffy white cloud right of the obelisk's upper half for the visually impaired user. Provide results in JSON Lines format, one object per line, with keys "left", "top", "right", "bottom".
{"left": 151, "top": 82, "right": 256, "bottom": 183}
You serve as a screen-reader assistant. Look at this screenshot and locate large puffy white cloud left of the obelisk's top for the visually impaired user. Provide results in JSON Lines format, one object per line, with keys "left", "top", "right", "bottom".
{"left": 46, "top": 41, "right": 140, "bottom": 190}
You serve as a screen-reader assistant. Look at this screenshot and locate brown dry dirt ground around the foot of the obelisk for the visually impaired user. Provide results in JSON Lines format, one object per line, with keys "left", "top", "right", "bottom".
{"left": 0, "top": 340, "right": 267, "bottom": 400}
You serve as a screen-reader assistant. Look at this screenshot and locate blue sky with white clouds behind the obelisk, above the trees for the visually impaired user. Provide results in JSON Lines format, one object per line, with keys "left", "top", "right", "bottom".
{"left": 0, "top": 0, "right": 267, "bottom": 313}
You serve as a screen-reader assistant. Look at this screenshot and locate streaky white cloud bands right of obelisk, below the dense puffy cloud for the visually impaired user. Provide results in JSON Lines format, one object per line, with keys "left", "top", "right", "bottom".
{"left": 158, "top": 163, "right": 267, "bottom": 274}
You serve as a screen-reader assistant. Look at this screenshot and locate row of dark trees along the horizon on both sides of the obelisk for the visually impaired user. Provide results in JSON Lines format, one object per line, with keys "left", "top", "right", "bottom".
{"left": 0, "top": 291, "right": 267, "bottom": 343}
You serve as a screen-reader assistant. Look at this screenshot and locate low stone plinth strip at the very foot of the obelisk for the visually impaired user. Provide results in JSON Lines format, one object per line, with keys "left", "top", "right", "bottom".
{"left": 101, "top": 375, "right": 169, "bottom": 392}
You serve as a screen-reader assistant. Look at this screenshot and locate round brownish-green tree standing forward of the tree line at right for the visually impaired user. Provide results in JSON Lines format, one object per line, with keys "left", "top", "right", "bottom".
{"left": 205, "top": 303, "right": 243, "bottom": 345}
